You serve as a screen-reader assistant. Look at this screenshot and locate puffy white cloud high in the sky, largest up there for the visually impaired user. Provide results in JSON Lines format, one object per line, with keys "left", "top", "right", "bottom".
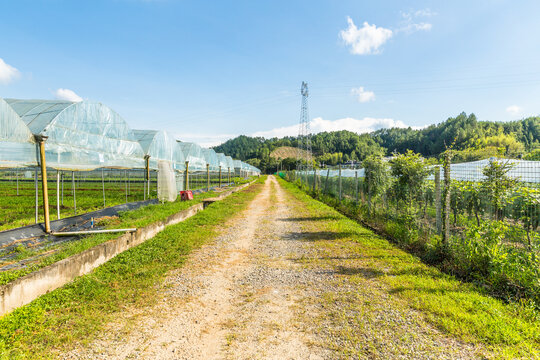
{"left": 339, "top": 17, "right": 392, "bottom": 55}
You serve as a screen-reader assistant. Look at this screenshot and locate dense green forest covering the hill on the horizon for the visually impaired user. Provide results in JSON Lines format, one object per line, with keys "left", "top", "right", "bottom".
{"left": 214, "top": 113, "right": 540, "bottom": 172}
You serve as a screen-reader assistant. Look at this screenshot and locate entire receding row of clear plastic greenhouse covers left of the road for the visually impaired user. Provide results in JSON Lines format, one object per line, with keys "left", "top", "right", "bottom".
{"left": 0, "top": 98, "right": 259, "bottom": 173}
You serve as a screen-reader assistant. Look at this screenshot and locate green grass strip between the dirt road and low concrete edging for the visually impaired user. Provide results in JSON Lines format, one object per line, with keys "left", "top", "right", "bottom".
{"left": 0, "top": 177, "right": 265, "bottom": 359}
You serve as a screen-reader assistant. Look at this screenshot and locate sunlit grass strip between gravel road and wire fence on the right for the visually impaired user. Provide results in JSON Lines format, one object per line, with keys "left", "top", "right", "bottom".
{"left": 279, "top": 179, "right": 540, "bottom": 359}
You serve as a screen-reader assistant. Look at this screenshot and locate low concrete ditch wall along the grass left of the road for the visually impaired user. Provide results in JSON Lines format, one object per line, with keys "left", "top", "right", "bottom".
{"left": 0, "top": 182, "right": 253, "bottom": 316}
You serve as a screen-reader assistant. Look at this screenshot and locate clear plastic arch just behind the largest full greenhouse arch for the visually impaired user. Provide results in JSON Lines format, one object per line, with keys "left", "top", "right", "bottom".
{"left": 133, "top": 130, "right": 186, "bottom": 171}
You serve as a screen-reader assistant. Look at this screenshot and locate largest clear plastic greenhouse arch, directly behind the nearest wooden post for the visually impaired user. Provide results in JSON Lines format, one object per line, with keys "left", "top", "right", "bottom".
{"left": 6, "top": 99, "right": 144, "bottom": 170}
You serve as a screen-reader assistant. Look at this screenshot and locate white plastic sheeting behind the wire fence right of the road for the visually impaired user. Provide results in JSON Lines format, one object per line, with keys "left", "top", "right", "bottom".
{"left": 299, "top": 159, "right": 540, "bottom": 183}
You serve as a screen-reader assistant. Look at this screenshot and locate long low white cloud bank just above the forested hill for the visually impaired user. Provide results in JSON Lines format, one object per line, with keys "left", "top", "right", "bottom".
{"left": 252, "top": 117, "right": 415, "bottom": 138}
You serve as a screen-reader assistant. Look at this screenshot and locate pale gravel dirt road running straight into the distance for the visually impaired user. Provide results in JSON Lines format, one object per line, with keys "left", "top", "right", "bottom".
{"left": 63, "top": 177, "right": 488, "bottom": 359}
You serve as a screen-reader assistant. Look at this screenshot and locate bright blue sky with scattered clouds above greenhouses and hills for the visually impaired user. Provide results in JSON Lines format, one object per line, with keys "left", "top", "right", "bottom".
{"left": 0, "top": 0, "right": 540, "bottom": 145}
